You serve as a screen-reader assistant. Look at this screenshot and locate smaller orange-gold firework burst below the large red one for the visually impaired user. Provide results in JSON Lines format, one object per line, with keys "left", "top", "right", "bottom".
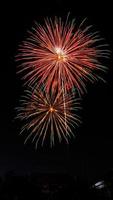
{"left": 17, "top": 88, "right": 80, "bottom": 148}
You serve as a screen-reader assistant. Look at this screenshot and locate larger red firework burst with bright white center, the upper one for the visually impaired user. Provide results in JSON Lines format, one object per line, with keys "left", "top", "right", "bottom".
{"left": 16, "top": 17, "right": 108, "bottom": 94}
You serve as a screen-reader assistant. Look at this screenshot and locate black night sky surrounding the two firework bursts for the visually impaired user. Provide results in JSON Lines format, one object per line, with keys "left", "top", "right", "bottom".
{"left": 0, "top": 0, "right": 113, "bottom": 184}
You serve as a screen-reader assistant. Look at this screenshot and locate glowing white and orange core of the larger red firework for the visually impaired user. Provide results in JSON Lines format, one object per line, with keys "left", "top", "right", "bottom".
{"left": 55, "top": 47, "right": 66, "bottom": 61}
